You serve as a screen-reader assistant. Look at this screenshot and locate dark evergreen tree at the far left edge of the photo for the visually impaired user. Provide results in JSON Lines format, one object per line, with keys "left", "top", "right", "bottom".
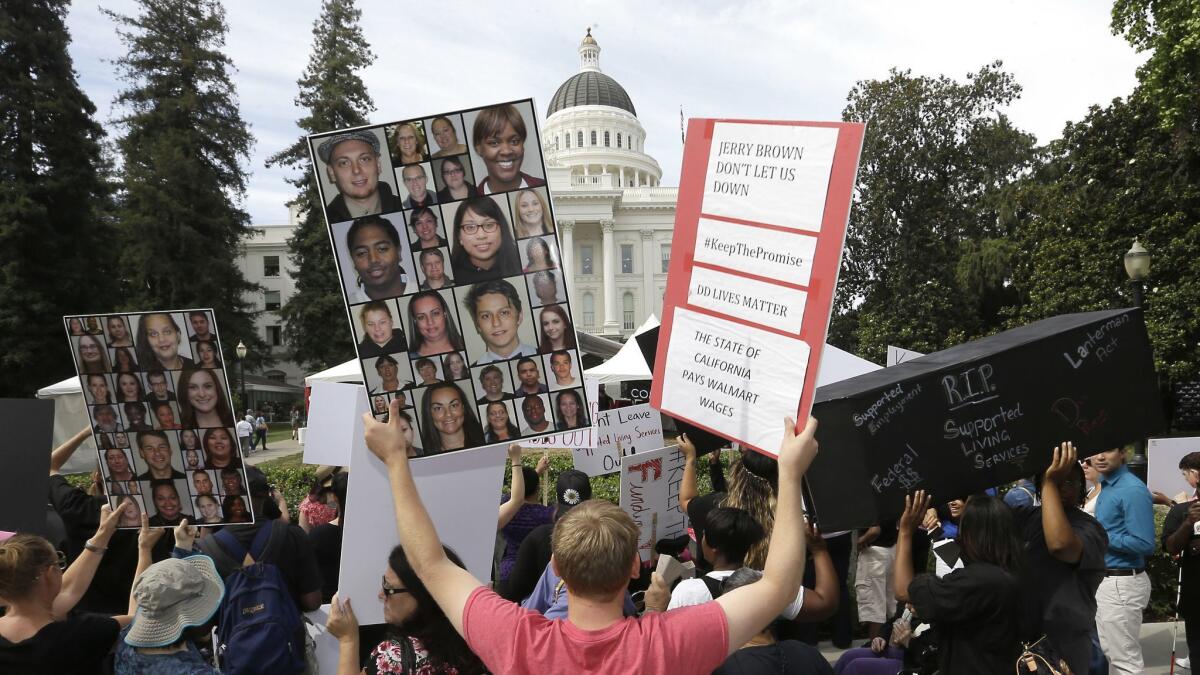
{"left": 0, "top": 0, "right": 116, "bottom": 396}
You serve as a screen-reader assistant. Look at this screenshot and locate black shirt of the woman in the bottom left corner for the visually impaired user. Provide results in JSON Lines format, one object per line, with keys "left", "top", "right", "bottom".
{"left": 0, "top": 614, "right": 121, "bottom": 675}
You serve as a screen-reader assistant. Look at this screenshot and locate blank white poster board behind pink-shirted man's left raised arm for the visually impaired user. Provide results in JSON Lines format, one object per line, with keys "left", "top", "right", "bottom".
{"left": 337, "top": 387, "right": 506, "bottom": 626}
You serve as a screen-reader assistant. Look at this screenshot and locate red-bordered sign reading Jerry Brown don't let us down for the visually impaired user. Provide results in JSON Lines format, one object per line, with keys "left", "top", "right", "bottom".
{"left": 650, "top": 119, "right": 865, "bottom": 455}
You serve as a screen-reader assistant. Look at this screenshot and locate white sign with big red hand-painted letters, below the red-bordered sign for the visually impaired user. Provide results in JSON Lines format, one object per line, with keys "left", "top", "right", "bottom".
{"left": 620, "top": 446, "right": 688, "bottom": 562}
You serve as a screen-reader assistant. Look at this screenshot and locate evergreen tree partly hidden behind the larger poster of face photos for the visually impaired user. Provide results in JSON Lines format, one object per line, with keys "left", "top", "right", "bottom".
{"left": 266, "top": 0, "right": 374, "bottom": 370}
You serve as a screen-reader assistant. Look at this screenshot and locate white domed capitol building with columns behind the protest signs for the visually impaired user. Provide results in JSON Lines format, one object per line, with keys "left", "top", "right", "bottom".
{"left": 240, "top": 30, "right": 679, "bottom": 386}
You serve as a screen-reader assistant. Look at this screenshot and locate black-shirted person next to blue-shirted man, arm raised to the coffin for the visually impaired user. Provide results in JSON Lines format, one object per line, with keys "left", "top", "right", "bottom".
{"left": 1006, "top": 442, "right": 1108, "bottom": 673}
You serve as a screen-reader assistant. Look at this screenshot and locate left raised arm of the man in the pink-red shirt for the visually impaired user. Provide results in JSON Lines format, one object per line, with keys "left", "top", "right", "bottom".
{"left": 362, "top": 399, "right": 482, "bottom": 634}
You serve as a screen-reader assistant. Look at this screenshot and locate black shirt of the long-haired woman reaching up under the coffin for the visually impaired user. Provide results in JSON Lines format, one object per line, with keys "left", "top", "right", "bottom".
{"left": 908, "top": 562, "right": 1021, "bottom": 675}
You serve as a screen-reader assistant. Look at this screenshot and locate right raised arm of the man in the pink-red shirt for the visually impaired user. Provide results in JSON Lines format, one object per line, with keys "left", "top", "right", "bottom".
{"left": 716, "top": 417, "right": 817, "bottom": 653}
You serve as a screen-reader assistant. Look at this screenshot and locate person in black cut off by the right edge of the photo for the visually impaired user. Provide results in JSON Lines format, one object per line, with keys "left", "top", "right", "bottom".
{"left": 1163, "top": 453, "right": 1200, "bottom": 668}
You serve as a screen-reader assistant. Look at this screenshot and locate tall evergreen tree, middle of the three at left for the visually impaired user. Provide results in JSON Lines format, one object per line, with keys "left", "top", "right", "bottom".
{"left": 106, "top": 0, "right": 269, "bottom": 366}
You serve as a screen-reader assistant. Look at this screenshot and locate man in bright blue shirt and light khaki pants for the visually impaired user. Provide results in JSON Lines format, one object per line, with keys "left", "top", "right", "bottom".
{"left": 1091, "top": 448, "right": 1156, "bottom": 673}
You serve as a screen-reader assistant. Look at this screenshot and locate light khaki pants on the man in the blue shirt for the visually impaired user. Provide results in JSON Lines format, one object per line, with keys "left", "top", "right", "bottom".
{"left": 1096, "top": 572, "right": 1150, "bottom": 674}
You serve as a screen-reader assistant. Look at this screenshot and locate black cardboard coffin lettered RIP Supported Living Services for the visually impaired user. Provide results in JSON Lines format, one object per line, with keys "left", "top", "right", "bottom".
{"left": 808, "top": 309, "right": 1164, "bottom": 532}
